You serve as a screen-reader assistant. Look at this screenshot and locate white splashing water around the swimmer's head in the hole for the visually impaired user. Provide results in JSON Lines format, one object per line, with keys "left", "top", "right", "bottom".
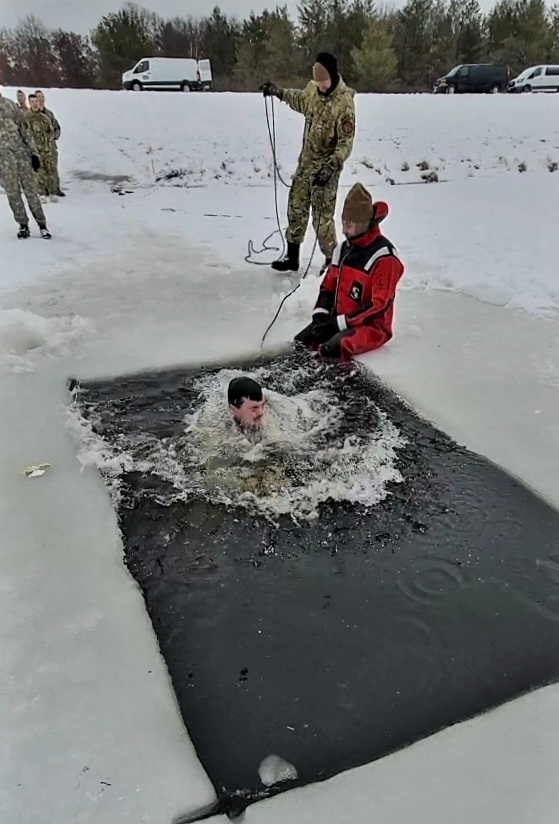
{"left": 71, "top": 360, "right": 406, "bottom": 521}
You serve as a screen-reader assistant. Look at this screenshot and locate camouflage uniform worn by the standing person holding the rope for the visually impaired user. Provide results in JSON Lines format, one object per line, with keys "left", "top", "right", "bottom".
{"left": 281, "top": 77, "right": 355, "bottom": 258}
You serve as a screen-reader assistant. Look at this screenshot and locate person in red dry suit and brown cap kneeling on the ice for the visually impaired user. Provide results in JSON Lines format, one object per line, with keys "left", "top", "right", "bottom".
{"left": 295, "top": 183, "right": 404, "bottom": 361}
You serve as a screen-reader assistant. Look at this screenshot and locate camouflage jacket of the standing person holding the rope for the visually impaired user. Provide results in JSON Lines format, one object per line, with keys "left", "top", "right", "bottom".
{"left": 282, "top": 77, "right": 355, "bottom": 171}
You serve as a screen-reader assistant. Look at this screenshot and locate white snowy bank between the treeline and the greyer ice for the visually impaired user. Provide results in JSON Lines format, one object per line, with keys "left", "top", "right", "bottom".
{"left": 6, "top": 89, "right": 559, "bottom": 186}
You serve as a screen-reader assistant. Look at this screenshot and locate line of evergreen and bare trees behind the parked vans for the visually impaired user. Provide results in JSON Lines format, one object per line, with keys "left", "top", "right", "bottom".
{"left": 0, "top": 0, "right": 559, "bottom": 92}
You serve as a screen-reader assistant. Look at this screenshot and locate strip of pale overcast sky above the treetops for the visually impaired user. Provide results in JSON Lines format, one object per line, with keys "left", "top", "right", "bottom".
{"left": 0, "top": 0, "right": 504, "bottom": 33}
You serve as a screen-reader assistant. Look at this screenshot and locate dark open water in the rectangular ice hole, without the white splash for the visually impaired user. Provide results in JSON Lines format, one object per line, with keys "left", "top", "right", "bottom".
{"left": 69, "top": 353, "right": 559, "bottom": 810}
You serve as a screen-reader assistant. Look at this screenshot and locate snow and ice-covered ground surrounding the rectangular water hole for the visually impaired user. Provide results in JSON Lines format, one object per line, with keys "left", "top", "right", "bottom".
{"left": 0, "top": 89, "right": 559, "bottom": 824}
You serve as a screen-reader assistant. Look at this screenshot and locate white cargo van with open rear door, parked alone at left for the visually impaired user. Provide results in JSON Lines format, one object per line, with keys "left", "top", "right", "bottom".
{"left": 122, "top": 57, "right": 212, "bottom": 92}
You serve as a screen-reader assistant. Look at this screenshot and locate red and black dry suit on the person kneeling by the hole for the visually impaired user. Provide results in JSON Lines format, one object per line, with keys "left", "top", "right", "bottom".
{"left": 313, "top": 201, "right": 404, "bottom": 360}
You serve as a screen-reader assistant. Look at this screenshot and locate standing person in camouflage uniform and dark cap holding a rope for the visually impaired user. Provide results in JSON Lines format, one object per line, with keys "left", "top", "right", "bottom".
{"left": 261, "top": 52, "right": 355, "bottom": 272}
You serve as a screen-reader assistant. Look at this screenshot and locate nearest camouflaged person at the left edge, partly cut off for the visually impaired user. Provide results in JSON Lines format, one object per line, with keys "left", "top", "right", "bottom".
{"left": 0, "top": 94, "right": 51, "bottom": 238}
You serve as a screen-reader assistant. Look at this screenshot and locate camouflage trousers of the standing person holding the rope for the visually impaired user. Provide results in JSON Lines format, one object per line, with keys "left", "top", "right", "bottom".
{"left": 287, "top": 167, "right": 340, "bottom": 257}
